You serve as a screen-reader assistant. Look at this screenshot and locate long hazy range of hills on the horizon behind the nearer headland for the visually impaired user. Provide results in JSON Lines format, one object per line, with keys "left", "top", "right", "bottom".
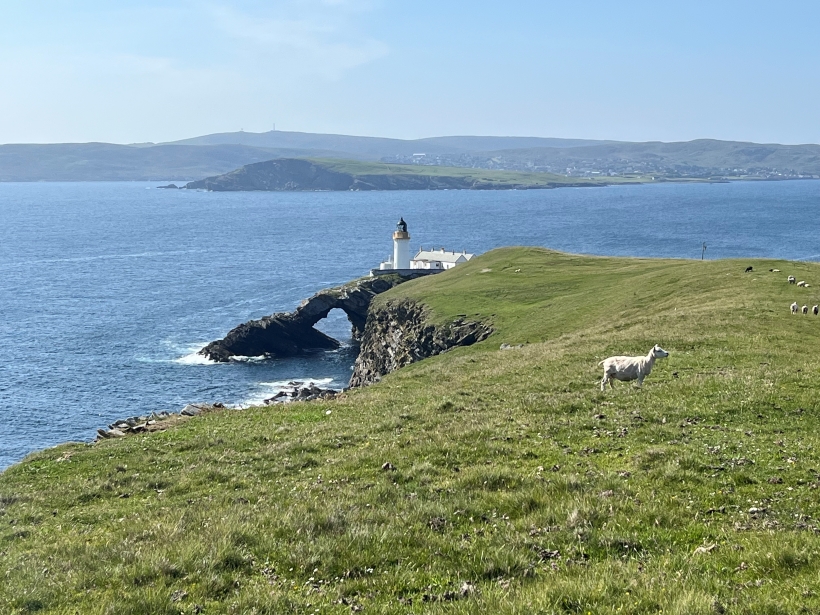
{"left": 0, "top": 131, "right": 820, "bottom": 181}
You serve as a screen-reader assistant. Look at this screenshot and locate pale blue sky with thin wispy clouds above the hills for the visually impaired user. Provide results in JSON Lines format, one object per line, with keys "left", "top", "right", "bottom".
{"left": 0, "top": 0, "right": 820, "bottom": 143}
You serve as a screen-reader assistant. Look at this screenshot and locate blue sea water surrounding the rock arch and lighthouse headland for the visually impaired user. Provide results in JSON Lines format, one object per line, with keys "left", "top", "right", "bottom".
{"left": 0, "top": 181, "right": 820, "bottom": 469}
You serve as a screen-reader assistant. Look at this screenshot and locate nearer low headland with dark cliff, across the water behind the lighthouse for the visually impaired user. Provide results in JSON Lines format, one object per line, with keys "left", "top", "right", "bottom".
{"left": 179, "top": 158, "right": 616, "bottom": 192}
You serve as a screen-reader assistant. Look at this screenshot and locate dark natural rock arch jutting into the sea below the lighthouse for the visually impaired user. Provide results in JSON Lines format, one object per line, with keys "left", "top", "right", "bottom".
{"left": 200, "top": 271, "right": 426, "bottom": 363}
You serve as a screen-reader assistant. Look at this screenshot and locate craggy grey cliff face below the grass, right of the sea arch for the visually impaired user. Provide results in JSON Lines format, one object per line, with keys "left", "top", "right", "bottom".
{"left": 350, "top": 299, "right": 493, "bottom": 387}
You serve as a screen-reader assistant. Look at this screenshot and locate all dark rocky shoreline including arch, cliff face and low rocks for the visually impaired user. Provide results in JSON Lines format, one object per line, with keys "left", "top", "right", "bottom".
{"left": 95, "top": 273, "right": 493, "bottom": 442}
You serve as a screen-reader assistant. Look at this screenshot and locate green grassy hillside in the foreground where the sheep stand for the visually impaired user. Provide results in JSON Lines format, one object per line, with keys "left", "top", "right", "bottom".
{"left": 0, "top": 248, "right": 820, "bottom": 614}
